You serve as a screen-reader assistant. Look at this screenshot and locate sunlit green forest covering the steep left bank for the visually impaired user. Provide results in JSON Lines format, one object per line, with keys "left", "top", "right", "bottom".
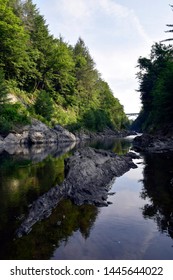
{"left": 0, "top": 0, "right": 128, "bottom": 134}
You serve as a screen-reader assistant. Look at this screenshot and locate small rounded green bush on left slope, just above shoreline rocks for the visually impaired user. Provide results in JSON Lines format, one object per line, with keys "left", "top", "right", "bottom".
{"left": 34, "top": 90, "right": 53, "bottom": 121}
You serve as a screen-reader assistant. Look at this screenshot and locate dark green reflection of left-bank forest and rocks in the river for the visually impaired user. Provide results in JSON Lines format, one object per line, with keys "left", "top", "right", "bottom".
{"left": 0, "top": 140, "right": 131, "bottom": 259}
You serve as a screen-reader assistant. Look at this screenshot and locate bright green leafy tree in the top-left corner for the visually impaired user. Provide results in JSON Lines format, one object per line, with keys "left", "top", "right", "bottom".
{"left": 0, "top": 0, "right": 28, "bottom": 79}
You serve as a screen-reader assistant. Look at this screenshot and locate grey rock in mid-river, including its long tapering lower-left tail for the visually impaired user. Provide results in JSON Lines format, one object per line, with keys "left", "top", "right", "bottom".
{"left": 17, "top": 148, "right": 136, "bottom": 237}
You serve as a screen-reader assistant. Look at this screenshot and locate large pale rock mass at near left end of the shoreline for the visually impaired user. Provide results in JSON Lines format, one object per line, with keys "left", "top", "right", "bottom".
{"left": 0, "top": 119, "right": 76, "bottom": 149}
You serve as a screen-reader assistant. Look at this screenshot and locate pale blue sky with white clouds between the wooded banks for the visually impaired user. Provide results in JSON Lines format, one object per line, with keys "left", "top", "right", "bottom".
{"left": 33, "top": 0, "right": 173, "bottom": 113}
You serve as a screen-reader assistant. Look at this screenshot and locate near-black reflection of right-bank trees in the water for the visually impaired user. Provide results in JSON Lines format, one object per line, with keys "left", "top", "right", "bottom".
{"left": 141, "top": 153, "right": 173, "bottom": 238}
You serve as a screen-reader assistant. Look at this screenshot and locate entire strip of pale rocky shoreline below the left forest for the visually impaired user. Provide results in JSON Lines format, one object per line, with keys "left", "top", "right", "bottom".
{"left": 0, "top": 119, "right": 136, "bottom": 152}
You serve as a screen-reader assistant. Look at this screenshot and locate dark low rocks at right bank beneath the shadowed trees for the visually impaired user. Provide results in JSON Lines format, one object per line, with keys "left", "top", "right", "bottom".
{"left": 133, "top": 134, "right": 173, "bottom": 153}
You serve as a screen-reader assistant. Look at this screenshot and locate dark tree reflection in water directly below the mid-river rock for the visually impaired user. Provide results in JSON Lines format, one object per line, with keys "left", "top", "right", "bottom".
{"left": 4, "top": 200, "right": 98, "bottom": 259}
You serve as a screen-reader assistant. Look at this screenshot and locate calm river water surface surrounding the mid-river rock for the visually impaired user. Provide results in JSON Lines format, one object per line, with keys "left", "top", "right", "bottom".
{"left": 0, "top": 138, "right": 173, "bottom": 260}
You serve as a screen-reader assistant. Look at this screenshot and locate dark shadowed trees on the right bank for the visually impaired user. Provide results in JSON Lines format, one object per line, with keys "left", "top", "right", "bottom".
{"left": 132, "top": 6, "right": 173, "bottom": 134}
